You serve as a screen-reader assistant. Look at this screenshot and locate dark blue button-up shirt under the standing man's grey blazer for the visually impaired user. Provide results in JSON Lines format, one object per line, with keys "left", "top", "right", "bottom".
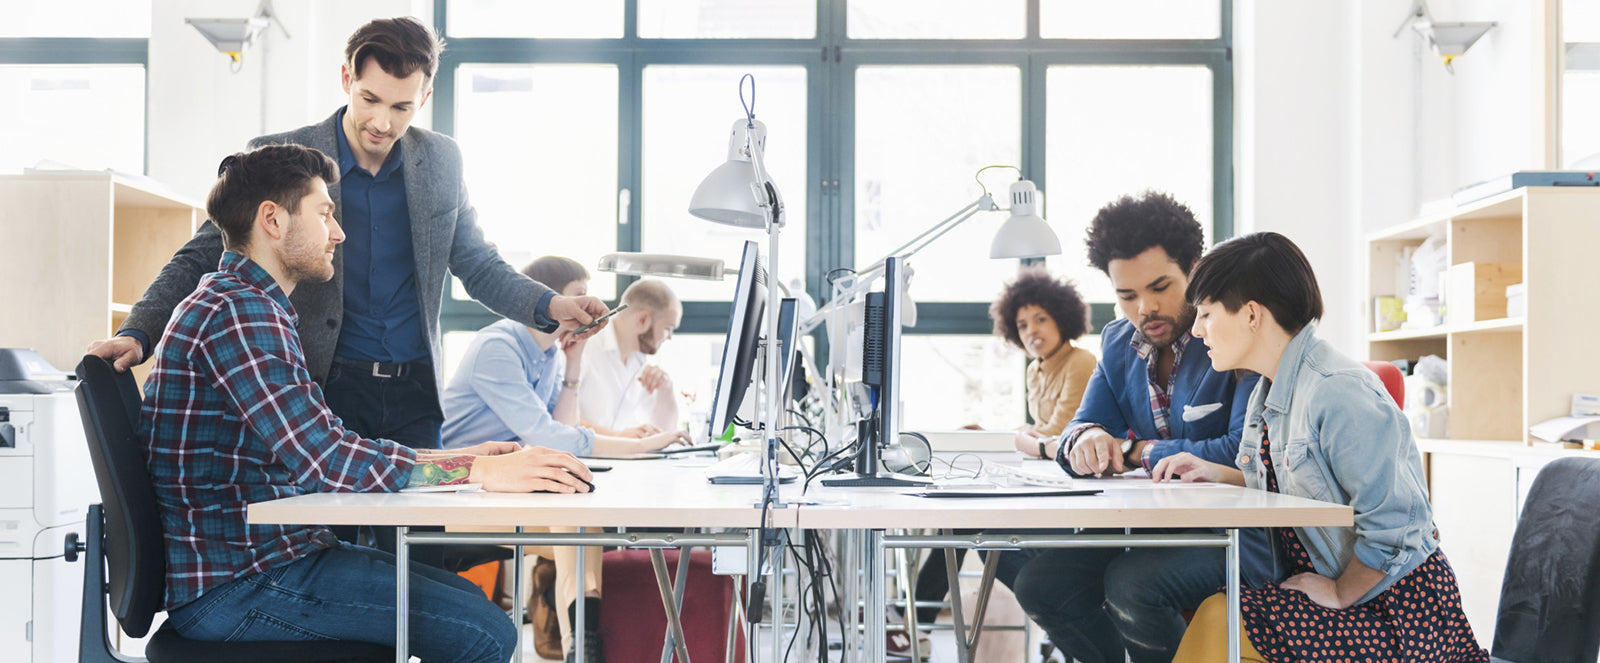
{"left": 336, "top": 111, "right": 429, "bottom": 362}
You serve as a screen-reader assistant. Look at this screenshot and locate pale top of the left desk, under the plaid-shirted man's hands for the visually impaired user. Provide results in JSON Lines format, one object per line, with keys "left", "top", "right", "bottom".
{"left": 248, "top": 460, "right": 795, "bottom": 527}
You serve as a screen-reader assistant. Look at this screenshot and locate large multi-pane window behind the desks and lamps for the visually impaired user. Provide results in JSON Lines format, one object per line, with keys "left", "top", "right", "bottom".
{"left": 435, "top": 0, "right": 1232, "bottom": 428}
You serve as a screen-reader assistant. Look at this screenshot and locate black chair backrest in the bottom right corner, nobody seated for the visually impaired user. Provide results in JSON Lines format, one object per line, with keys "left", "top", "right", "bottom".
{"left": 1493, "top": 458, "right": 1600, "bottom": 663}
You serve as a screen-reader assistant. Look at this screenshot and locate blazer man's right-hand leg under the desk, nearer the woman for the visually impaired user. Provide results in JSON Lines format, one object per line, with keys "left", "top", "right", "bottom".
{"left": 1106, "top": 548, "right": 1224, "bottom": 663}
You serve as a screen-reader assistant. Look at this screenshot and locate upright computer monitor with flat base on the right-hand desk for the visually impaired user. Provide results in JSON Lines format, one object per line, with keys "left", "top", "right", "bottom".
{"left": 822, "top": 256, "right": 928, "bottom": 487}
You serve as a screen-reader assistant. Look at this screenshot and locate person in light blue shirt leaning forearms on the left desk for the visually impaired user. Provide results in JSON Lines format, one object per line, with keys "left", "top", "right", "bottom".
{"left": 442, "top": 256, "right": 686, "bottom": 456}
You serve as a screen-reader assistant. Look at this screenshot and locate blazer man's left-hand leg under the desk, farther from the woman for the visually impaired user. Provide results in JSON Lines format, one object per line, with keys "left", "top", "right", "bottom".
{"left": 1000, "top": 544, "right": 1125, "bottom": 663}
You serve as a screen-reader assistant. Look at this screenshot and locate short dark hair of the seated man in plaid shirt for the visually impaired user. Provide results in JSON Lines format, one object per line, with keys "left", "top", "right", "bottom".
{"left": 205, "top": 144, "right": 339, "bottom": 251}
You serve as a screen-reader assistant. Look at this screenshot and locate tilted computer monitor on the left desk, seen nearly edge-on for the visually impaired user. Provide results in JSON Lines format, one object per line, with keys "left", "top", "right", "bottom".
{"left": 706, "top": 242, "right": 766, "bottom": 440}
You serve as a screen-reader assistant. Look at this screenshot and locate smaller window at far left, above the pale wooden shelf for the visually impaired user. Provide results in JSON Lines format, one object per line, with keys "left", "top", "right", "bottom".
{"left": 0, "top": 0, "right": 150, "bottom": 175}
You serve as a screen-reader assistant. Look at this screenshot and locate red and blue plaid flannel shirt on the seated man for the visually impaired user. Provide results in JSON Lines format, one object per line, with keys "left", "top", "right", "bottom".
{"left": 141, "top": 251, "right": 416, "bottom": 609}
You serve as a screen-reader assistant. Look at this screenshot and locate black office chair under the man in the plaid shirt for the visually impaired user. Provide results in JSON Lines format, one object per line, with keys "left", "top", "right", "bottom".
{"left": 66, "top": 356, "right": 395, "bottom": 663}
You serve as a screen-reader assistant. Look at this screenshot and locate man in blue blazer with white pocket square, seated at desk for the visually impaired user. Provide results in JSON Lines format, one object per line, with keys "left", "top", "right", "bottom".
{"left": 1008, "top": 192, "right": 1264, "bottom": 663}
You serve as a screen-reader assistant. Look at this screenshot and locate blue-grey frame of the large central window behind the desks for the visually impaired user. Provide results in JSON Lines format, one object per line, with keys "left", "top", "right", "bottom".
{"left": 434, "top": 0, "right": 1234, "bottom": 341}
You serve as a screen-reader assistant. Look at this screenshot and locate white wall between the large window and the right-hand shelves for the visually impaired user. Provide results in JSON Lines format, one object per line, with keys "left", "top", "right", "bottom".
{"left": 1235, "top": 0, "right": 1544, "bottom": 356}
